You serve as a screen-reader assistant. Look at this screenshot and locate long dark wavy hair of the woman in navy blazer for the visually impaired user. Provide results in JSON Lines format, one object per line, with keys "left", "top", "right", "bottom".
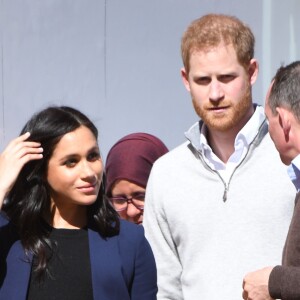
{"left": 3, "top": 106, "right": 120, "bottom": 278}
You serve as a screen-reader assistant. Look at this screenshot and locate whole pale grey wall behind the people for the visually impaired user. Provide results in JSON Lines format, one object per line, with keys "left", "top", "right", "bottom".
{"left": 0, "top": 0, "right": 300, "bottom": 158}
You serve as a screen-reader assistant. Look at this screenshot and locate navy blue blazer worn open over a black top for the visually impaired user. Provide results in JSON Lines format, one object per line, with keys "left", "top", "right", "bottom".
{"left": 0, "top": 215, "right": 157, "bottom": 300}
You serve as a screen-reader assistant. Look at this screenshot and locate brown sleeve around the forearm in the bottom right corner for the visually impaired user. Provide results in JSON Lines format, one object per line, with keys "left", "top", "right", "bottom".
{"left": 269, "top": 266, "right": 300, "bottom": 300}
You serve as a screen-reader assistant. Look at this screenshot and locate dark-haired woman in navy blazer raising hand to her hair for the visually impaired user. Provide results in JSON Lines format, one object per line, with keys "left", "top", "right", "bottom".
{"left": 0, "top": 107, "right": 157, "bottom": 300}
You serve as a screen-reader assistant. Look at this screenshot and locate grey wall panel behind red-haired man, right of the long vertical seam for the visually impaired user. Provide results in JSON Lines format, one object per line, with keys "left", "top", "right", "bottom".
{"left": 102, "top": 0, "right": 262, "bottom": 158}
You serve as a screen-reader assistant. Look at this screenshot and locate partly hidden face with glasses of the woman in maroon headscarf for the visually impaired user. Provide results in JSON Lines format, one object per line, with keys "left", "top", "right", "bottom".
{"left": 111, "top": 179, "right": 145, "bottom": 224}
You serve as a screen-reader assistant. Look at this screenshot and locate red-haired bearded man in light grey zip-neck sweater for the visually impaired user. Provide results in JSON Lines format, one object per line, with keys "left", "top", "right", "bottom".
{"left": 143, "top": 14, "right": 295, "bottom": 300}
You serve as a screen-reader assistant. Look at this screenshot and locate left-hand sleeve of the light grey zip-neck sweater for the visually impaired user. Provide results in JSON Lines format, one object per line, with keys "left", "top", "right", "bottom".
{"left": 143, "top": 164, "right": 183, "bottom": 300}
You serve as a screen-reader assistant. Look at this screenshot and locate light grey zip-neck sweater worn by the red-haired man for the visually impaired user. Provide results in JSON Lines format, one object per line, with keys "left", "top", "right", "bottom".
{"left": 143, "top": 112, "right": 295, "bottom": 300}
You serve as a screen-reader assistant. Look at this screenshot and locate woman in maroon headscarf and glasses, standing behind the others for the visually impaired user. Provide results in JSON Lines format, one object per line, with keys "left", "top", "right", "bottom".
{"left": 105, "top": 133, "right": 168, "bottom": 224}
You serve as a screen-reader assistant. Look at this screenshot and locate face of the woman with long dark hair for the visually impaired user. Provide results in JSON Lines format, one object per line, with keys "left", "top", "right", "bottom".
{"left": 47, "top": 126, "right": 103, "bottom": 211}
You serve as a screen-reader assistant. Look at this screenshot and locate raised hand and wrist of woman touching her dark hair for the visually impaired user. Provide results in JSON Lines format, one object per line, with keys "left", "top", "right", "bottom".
{"left": 0, "top": 132, "right": 43, "bottom": 209}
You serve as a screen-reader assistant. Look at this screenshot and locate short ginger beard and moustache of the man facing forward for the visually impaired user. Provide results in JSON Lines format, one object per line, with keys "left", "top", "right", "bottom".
{"left": 192, "top": 88, "right": 252, "bottom": 132}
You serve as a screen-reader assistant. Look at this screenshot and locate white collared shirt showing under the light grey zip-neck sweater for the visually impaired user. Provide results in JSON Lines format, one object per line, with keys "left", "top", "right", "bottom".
{"left": 200, "top": 106, "right": 265, "bottom": 182}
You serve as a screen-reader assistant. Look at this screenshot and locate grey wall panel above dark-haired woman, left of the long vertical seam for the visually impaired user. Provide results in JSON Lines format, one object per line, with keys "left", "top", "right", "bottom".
{"left": 1, "top": 0, "right": 105, "bottom": 152}
